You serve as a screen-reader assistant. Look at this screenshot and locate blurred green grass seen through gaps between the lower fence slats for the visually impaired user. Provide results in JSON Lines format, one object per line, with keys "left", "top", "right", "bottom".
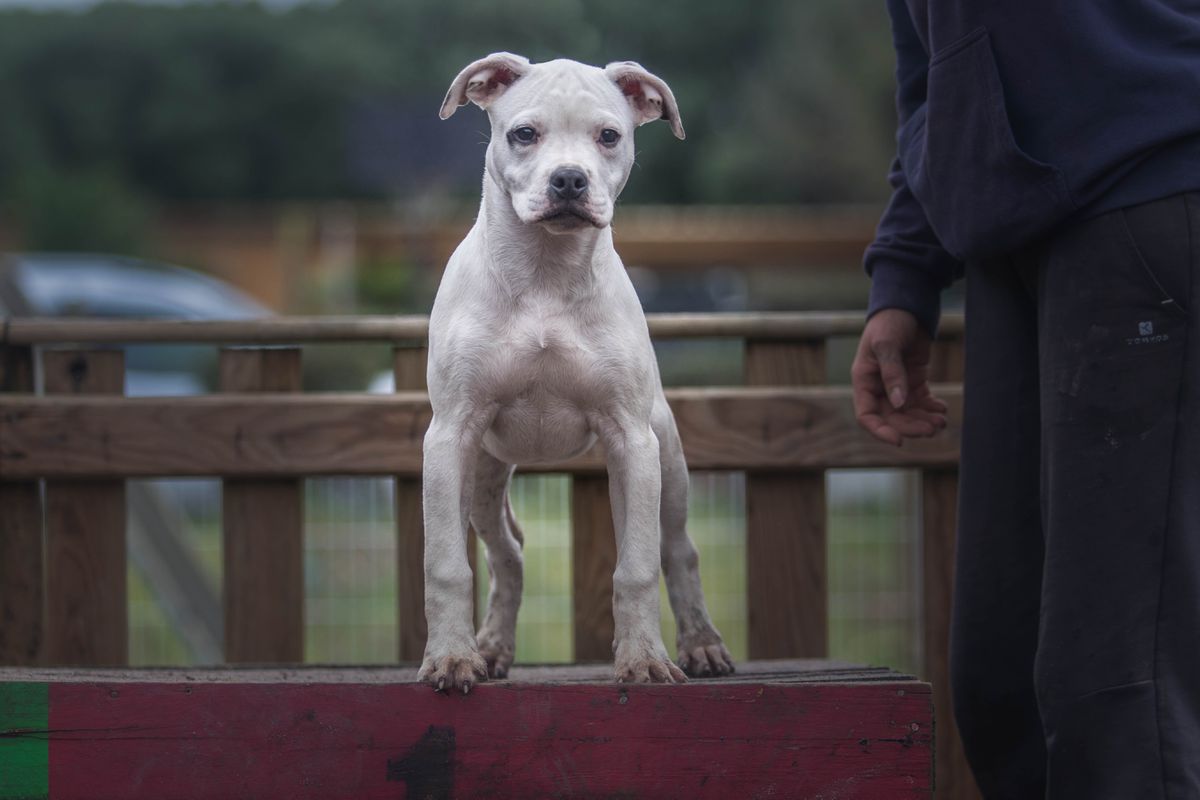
{"left": 130, "top": 473, "right": 920, "bottom": 672}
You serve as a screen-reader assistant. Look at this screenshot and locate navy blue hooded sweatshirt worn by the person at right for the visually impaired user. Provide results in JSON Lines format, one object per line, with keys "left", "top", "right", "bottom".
{"left": 865, "top": 0, "right": 1200, "bottom": 332}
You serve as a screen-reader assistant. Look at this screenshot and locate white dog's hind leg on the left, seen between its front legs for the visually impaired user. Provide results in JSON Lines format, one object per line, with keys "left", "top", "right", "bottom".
{"left": 470, "top": 450, "right": 524, "bottom": 678}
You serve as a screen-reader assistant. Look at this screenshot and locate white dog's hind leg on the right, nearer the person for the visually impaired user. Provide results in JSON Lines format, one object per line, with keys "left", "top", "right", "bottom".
{"left": 653, "top": 395, "right": 733, "bottom": 676}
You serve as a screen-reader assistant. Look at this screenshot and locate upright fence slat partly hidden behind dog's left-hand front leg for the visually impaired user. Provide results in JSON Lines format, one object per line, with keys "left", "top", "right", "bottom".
{"left": 394, "top": 347, "right": 427, "bottom": 661}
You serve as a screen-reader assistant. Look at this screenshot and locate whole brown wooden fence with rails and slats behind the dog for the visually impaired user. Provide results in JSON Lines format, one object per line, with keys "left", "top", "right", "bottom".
{"left": 0, "top": 313, "right": 973, "bottom": 798}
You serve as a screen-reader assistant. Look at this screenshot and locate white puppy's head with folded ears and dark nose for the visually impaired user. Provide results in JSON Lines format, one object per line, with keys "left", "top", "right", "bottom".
{"left": 442, "top": 53, "right": 684, "bottom": 233}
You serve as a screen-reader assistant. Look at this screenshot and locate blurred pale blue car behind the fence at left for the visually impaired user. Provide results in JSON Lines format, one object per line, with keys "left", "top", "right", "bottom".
{"left": 0, "top": 253, "right": 271, "bottom": 396}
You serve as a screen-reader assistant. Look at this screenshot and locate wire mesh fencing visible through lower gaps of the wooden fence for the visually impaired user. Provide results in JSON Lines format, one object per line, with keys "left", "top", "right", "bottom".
{"left": 128, "top": 470, "right": 920, "bottom": 672}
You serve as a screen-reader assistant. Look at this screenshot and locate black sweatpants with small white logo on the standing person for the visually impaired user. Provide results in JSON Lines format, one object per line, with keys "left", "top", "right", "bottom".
{"left": 950, "top": 193, "right": 1200, "bottom": 800}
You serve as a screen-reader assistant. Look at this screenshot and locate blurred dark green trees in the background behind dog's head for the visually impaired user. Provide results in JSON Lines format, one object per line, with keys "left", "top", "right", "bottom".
{"left": 0, "top": 0, "right": 893, "bottom": 215}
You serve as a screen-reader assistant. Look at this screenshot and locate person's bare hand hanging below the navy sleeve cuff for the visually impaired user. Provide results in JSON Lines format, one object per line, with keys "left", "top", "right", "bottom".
{"left": 850, "top": 308, "right": 946, "bottom": 447}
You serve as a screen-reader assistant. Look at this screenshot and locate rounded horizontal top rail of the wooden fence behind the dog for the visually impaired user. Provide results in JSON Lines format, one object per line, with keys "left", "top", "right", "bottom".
{"left": 7, "top": 311, "right": 962, "bottom": 344}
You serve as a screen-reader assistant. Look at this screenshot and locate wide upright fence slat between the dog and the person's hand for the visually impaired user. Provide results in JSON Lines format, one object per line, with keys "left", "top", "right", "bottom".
{"left": 744, "top": 339, "right": 829, "bottom": 658}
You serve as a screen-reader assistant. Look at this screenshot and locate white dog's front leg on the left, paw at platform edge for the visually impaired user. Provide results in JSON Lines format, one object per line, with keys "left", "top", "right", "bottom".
{"left": 418, "top": 414, "right": 490, "bottom": 694}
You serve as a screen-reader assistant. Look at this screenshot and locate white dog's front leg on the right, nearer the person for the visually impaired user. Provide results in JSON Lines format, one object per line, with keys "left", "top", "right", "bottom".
{"left": 598, "top": 420, "right": 688, "bottom": 684}
